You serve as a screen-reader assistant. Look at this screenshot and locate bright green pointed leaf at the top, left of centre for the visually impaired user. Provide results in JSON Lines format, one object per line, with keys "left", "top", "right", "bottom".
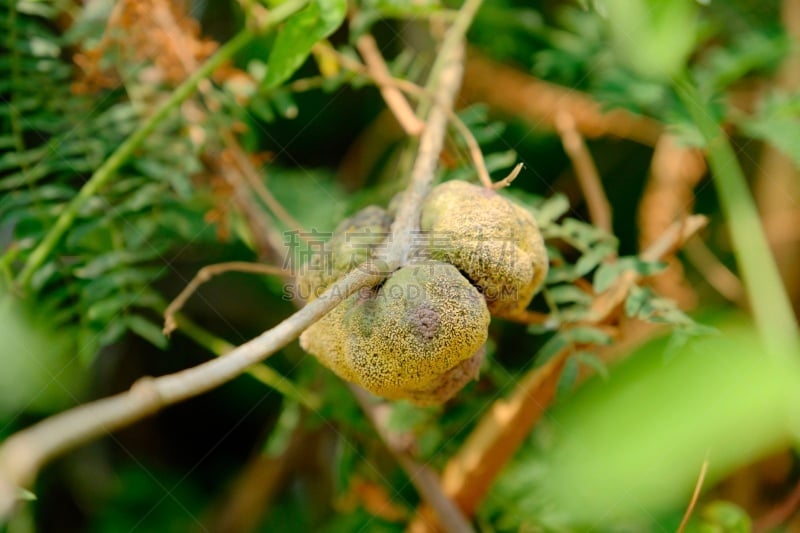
{"left": 264, "top": 0, "right": 347, "bottom": 89}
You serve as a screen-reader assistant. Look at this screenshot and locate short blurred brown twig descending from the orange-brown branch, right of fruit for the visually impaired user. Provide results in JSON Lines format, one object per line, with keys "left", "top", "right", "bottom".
{"left": 556, "top": 111, "right": 614, "bottom": 233}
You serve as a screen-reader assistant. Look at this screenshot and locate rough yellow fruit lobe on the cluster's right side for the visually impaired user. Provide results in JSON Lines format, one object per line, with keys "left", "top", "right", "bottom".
{"left": 421, "top": 181, "right": 548, "bottom": 317}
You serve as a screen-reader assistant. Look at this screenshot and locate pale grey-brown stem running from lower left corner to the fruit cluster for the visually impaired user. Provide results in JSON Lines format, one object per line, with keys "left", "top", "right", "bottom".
{"left": 0, "top": 269, "right": 382, "bottom": 519}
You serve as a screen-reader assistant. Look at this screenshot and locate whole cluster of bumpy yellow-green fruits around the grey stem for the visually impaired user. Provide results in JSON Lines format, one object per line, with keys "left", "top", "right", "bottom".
{"left": 297, "top": 181, "right": 547, "bottom": 405}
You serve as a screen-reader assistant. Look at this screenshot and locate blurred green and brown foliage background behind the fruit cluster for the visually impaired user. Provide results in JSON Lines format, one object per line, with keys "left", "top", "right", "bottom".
{"left": 0, "top": 0, "right": 800, "bottom": 532}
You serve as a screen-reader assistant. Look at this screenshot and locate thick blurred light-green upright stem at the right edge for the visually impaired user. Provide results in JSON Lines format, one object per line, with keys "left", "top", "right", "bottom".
{"left": 674, "top": 75, "right": 800, "bottom": 359}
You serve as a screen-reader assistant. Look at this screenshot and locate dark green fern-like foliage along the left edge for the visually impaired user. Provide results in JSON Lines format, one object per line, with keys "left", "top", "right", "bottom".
{"left": 0, "top": 2, "right": 219, "bottom": 362}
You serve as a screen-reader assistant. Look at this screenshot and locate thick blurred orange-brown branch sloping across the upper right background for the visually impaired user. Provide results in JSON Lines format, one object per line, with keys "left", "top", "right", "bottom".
{"left": 462, "top": 50, "right": 663, "bottom": 146}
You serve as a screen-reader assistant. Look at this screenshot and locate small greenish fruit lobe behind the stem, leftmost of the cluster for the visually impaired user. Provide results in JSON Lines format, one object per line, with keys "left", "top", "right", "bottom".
{"left": 297, "top": 205, "right": 391, "bottom": 302}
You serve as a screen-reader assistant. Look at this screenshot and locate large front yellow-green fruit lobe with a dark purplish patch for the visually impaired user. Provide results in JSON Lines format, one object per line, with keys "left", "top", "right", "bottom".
{"left": 300, "top": 262, "right": 490, "bottom": 405}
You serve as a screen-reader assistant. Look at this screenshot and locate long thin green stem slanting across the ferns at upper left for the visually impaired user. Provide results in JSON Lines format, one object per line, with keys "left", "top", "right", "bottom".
{"left": 17, "top": 0, "right": 308, "bottom": 288}
